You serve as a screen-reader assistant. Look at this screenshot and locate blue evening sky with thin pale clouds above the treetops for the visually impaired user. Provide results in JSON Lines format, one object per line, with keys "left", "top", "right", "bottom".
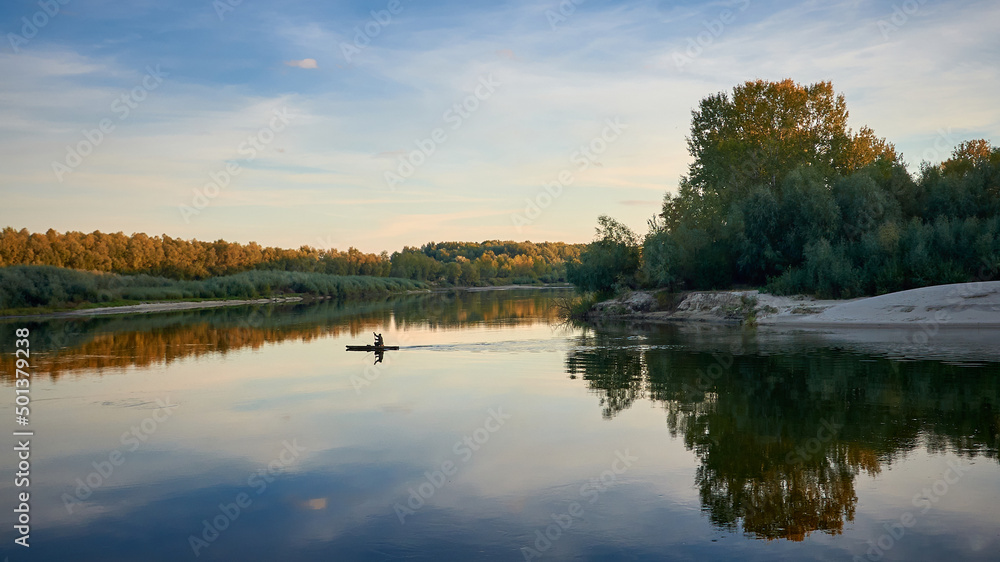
{"left": 0, "top": 0, "right": 1000, "bottom": 252}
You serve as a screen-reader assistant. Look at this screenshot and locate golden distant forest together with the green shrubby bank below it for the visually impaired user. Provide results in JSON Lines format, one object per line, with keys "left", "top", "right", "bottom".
{"left": 0, "top": 232, "right": 584, "bottom": 312}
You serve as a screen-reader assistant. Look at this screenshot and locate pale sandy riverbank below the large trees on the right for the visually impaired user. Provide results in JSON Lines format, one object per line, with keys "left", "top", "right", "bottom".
{"left": 587, "top": 281, "right": 1000, "bottom": 328}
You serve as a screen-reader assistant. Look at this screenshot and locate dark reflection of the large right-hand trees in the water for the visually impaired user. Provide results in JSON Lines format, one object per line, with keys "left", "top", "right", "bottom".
{"left": 566, "top": 332, "right": 1000, "bottom": 540}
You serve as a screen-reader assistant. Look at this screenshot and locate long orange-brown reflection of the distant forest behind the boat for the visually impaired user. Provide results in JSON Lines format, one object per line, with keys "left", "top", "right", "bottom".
{"left": 0, "top": 290, "right": 572, "bottom": 378}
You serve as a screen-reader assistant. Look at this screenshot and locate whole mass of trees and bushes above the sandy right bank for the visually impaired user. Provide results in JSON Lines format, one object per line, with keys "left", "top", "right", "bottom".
{"left": 568, "top": 80, "right": 1000, "bottom": 298}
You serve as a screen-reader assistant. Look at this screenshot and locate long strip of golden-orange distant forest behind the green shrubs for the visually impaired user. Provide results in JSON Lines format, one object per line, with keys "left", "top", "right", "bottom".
{"left": 0, "top": 227, "right": 584, "bottom": 285}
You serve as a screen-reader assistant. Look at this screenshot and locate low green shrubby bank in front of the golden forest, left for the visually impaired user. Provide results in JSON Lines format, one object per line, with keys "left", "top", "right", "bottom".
{"left": 0, "top": 266, "right": 427, "bottom": 312}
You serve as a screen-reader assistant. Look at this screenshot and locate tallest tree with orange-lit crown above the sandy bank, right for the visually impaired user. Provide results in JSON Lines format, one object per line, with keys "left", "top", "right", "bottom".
{"left": 656, "top": 80, "right": 900, "bottom": 288}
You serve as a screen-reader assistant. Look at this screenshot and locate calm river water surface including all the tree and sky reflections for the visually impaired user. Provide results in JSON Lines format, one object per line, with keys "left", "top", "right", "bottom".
{"left": 0, "top": 290, "right": 1000, "bottom": 560}
